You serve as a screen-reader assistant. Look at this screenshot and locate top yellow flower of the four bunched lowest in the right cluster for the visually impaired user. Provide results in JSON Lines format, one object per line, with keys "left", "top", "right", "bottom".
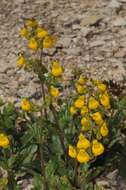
{"left": 77, "top": 133, "right": 90, "bottom": 149}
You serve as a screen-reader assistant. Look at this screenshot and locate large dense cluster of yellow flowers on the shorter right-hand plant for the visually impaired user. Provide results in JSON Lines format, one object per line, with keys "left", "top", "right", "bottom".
{"left": 68, "top": 75, "right": 111, "bottom": 163}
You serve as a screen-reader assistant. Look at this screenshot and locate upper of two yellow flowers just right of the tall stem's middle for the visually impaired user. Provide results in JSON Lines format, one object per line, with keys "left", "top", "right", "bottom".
{"left": 51, "top": 61, "right": 63, "bottom": 77}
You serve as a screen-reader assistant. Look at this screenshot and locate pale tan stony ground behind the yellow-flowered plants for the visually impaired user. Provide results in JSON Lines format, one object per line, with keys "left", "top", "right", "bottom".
{"left": 0, "top": 0, "right": 126, "bottom": 101}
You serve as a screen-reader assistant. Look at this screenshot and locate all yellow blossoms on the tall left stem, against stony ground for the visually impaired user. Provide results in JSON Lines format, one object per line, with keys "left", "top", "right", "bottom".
{"left": 17, "top": 19, "right": 63, "bottom": 102}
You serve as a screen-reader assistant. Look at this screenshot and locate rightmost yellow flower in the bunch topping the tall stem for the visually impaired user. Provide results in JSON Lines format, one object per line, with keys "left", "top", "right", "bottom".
{"left": 43, "top": 36, "right": 56, "bottom": 48}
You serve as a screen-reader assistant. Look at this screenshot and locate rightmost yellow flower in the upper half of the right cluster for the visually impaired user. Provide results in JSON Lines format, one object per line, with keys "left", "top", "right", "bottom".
{"left": 100, "top": 92, "right": 110, "bottom": 109}
